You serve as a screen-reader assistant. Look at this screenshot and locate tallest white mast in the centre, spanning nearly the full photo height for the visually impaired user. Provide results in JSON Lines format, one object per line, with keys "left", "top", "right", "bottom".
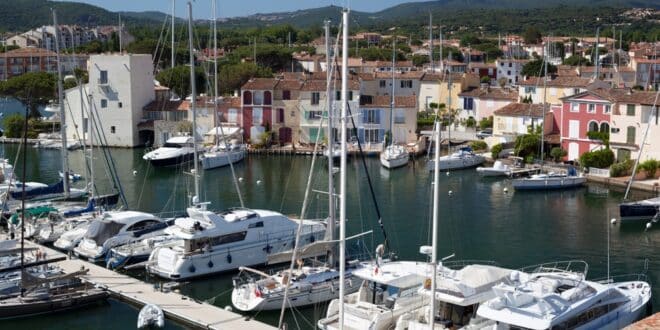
{"left": 339, "top": 8, "right": 348, "bottom": 330}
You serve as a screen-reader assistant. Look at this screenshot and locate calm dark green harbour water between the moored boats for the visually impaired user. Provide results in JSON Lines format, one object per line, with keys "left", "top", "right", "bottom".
{"left": 0, "top": 145, "right": 660, "bottom": 329}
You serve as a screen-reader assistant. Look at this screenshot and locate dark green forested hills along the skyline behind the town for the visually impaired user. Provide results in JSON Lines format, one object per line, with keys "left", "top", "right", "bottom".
{"left": 0, "top": 0, "right": 660, "bottom": 32}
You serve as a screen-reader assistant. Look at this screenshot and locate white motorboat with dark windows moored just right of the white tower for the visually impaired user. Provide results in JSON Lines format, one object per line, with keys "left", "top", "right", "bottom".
{"left": 142, "top": 136, "right": 195, "bottom": 166}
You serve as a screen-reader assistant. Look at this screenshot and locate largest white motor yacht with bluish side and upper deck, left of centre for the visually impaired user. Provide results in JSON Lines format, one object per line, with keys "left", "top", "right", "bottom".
{"left": 147, "top": 204, "right": 326, "bottom": 280}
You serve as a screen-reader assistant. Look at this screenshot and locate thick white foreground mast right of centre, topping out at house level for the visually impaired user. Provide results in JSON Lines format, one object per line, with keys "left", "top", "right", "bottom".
{"left": 429, "top": 120, "right": 440, "bottom": 329}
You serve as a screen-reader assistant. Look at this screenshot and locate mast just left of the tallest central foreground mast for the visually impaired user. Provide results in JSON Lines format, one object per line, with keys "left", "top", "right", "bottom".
{"left": 325, "top": 21, "right": 337, "bottom": 266}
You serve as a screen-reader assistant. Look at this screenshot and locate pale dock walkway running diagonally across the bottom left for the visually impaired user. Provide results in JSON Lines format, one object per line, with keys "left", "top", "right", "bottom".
{"left": 18, "top": 241, "right": 276, "bottom": 330}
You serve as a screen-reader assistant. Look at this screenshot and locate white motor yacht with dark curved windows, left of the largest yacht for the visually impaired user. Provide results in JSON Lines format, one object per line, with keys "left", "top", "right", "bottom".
{"left": 73, "top": 211, "right": 167, "bottom": 261}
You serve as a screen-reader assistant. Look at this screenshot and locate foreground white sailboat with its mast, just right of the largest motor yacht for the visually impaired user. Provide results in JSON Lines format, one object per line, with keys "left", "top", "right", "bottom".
{"left": 232, "top": 22, "right": 368, "bottom": 315}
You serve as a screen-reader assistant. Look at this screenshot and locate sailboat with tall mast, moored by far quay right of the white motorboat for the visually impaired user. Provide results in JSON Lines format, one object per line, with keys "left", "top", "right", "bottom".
{"left": 200, "top": 10, "right": 247, "bottom": 170}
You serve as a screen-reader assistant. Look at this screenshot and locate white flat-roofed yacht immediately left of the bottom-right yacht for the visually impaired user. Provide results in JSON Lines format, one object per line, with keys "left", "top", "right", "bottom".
{"left": 395, "top": 262, "right": 513, "bottom": 330}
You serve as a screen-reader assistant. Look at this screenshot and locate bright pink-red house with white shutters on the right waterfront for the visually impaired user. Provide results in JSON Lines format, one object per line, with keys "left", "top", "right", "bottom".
{"left": 558, "top": 89, "right": 614, "bottom": 160}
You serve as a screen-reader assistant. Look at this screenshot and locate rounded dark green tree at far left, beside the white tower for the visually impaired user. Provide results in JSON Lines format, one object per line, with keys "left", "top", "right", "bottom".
{"left": 0, "top": 72, "right": 57, "bottom": 117}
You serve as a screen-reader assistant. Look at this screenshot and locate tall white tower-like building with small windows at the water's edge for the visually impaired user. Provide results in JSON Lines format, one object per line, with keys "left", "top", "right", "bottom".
{"left": 64, "top": 54, "right": 155, "bottom": 147}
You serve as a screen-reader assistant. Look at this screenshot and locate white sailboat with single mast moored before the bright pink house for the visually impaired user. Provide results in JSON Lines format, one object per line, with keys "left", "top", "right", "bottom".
{"left": 512, "top": 46, "right": 587, "bottom": 190}
